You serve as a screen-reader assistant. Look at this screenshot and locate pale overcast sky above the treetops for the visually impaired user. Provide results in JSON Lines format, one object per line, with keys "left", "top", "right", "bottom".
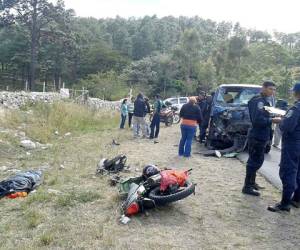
{"left": 65, "top": 0, "right": 300, "bottom": 32}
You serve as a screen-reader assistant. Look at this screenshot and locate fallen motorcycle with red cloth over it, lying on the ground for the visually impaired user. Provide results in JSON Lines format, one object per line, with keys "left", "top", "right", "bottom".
{"left": 119, "top": 165, "right": 196, "bottom": 216}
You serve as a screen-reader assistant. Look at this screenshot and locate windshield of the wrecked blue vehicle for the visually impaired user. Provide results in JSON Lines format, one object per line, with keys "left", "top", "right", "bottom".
{"left": 216, "top": 87, "right": 261, "bottom": 106}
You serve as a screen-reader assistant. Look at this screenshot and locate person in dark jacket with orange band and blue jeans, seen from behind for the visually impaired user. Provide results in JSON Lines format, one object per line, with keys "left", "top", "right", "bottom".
{"left": 178, "top": 97, "right": 202, "bottom": 157}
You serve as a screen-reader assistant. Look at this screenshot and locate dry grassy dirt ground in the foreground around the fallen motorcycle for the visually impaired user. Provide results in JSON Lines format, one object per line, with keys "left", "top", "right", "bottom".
{"left": 0, "top": 121, "right": 300, "bottom": 249}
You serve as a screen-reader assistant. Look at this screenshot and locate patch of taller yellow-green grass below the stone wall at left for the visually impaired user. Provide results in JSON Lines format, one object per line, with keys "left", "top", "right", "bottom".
{"left": 0, "top": 102, "right": 119, "bottom": 143}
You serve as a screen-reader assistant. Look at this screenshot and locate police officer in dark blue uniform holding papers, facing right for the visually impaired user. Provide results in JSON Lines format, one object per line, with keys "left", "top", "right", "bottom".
{"left": 242, "top": 81, "right": 281, "bottom": 196}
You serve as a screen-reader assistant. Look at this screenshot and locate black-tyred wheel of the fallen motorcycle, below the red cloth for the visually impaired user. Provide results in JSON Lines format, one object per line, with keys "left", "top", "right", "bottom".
{"left": 149, "top": 181, "right": 195, "bottom": 205}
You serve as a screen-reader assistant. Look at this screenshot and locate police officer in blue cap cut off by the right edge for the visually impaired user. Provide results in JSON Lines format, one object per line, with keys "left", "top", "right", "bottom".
{"left": 268, "top": 83, "right": 300, "bottom": 212}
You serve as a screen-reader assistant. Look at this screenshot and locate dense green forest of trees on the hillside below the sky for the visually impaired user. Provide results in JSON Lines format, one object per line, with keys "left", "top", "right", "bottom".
{"left": 0, "top": 0, "right": 300, "bottom": 99}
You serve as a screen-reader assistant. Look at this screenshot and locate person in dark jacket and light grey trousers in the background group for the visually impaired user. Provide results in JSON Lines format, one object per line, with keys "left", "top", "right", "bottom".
{"left": 132, "top": 93, "right": 147, "bottom": 138}
